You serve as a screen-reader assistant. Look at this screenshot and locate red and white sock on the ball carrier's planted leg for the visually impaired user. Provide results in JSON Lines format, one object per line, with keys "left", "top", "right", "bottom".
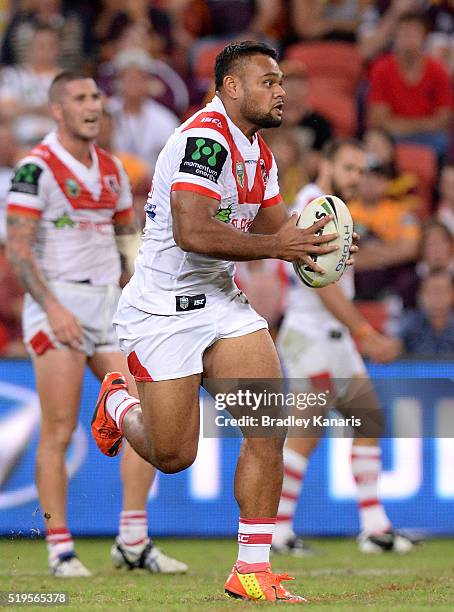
{"left": 236, "top": 518, "right": 276, "bottom": 574}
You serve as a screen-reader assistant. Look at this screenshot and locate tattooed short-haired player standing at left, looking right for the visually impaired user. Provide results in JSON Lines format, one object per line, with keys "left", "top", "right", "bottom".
{"left": 7, "top": 72, "right": 187, "bottom": 577}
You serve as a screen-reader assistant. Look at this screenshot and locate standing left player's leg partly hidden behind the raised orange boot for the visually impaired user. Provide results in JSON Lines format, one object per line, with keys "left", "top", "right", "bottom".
{"left": 88, "top": 350, "right": 187, "bottom": 573}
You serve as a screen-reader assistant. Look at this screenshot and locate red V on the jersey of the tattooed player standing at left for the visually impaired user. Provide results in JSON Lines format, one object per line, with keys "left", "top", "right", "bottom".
{"left": 31, "top": 144, "right": 120, "bottom": 210}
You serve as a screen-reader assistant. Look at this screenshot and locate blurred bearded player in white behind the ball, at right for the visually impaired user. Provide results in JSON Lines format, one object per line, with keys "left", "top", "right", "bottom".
{"left": 273, "top": 139, "right": 412, "bottom": 555}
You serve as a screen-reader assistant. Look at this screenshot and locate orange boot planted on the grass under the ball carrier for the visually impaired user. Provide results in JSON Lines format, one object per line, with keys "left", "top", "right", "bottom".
{"left": 224, "top": 565, "right": 307, "bottom": 603}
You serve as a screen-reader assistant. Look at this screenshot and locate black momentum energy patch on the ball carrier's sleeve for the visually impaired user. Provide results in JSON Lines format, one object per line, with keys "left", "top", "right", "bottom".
{"left": 180, "top": 136, "right": 227, "bottom": 183}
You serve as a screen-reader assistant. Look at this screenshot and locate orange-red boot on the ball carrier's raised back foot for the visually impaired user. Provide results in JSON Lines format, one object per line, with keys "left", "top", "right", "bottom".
{"left": 91, "top": 372, "right": 128, "bottom": 457}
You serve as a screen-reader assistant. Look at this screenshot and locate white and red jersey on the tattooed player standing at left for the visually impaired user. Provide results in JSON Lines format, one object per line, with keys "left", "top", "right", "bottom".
{"left": 8, "top": 132, "right": 133, "bottom": 285}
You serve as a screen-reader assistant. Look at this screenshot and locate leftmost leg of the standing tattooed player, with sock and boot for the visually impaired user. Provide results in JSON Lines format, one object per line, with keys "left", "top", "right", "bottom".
{"left": 34, "top": 349, "right": 90, "bottom": 576}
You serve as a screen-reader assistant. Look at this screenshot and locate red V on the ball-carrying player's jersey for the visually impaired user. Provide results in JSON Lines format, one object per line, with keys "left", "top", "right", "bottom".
{"left": 183, "top": 111, "right": 273, "bottom": 205}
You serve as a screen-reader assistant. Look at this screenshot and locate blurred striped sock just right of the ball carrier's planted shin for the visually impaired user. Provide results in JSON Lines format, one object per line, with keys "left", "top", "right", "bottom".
{"left": 273, "top": 447, "right": 308, "bottom": 547}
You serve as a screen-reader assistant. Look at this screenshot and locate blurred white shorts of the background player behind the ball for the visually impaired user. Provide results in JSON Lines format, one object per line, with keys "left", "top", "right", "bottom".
{"left": 276, "top": 320, "right": 367, "bottom": 392}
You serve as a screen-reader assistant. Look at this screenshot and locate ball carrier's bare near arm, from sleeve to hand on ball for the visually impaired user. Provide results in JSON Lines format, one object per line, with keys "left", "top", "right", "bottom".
{"left": 171, "top": 190, "right": 337, "bottom": 272}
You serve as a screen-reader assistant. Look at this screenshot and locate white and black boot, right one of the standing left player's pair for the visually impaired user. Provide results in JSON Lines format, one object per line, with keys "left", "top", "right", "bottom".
{"left": 110, "top": 538, "right": 188, "bottom": 574}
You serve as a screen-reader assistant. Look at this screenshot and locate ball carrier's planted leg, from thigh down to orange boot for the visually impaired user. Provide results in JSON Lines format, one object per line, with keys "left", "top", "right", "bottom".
{"left": 204, "top": 329, "right": 302, "bottom": 601}
